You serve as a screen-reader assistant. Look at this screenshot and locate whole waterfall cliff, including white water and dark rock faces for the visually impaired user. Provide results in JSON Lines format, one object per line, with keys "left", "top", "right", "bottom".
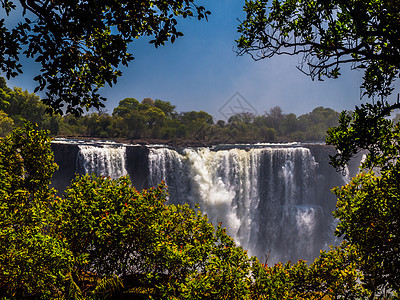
{"left": 52, "top": 140, "right": 359, "bottom": 263}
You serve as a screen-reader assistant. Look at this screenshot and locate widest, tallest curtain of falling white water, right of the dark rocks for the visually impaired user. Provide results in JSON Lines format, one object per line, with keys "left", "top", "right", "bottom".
{"left": 149, "top": 147, "right": 346, "bottom": 263}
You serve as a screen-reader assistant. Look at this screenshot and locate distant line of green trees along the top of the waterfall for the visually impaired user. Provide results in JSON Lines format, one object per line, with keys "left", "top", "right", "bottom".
{"left": 0, "top": 78, "right": 339, "bottom": 143}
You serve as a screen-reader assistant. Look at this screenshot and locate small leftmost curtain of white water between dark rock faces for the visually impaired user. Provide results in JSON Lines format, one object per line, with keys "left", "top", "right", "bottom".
{"left": 76, "top": 145, "right": 128, "bottom": 179}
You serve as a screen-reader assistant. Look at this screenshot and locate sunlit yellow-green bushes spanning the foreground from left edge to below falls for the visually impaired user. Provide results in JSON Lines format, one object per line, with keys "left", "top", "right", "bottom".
{"left": 0, "top": 124, "right": 398, "bottom": 299}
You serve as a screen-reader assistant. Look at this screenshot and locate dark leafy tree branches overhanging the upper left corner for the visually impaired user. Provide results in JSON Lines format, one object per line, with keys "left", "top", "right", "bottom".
{"left": 0, "top": 0, "right": 209, "bottom": 114}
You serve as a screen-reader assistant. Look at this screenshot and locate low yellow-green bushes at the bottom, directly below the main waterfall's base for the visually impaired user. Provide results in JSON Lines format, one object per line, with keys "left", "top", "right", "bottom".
{"left": 251, "top": 244, "right": 371, "bottom": 300}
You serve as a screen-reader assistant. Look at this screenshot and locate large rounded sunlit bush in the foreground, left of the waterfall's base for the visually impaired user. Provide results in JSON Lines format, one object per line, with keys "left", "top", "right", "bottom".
{"left": 50, "top": 175, "right": 255, "bottom": 299}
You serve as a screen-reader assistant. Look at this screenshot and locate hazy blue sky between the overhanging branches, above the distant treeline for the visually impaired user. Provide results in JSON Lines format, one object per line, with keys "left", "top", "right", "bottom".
{"left": 5, "top": 0, "right": 368, "bottom": 119}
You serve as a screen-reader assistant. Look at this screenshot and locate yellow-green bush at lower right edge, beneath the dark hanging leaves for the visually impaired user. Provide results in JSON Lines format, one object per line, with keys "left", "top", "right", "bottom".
{"left": 334, "top": 169, "right": 400, "bottom": 293}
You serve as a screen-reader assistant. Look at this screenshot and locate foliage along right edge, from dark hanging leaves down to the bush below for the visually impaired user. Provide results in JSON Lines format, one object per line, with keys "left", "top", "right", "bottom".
{"left": 327, "top": 102, "right": 400, "bottom": 294}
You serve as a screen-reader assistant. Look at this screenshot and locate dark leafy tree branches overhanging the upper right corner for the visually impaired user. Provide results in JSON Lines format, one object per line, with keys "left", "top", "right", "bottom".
{"left": 237, "top": 0, "right": 400, "bottom": 101}
